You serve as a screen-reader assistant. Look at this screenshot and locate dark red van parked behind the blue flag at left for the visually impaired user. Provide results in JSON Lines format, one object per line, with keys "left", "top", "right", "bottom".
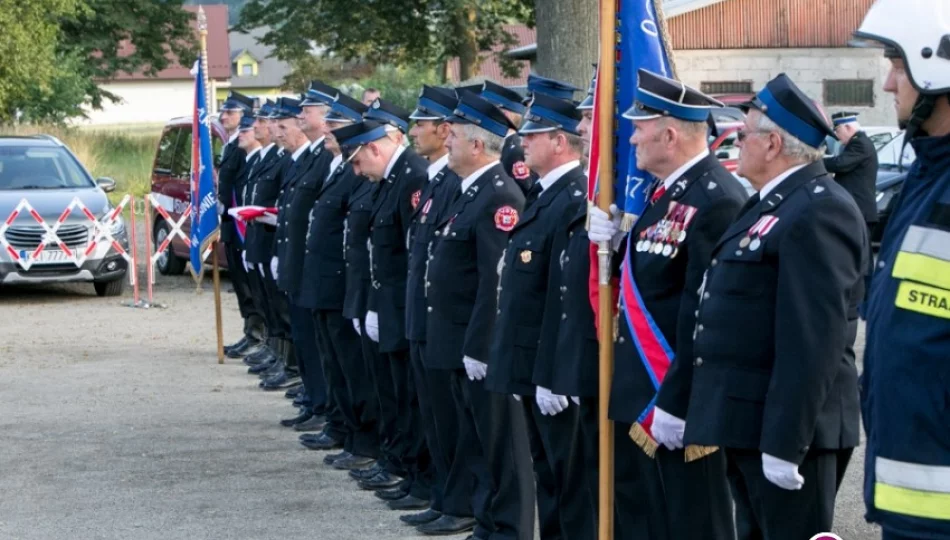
{"left": 152, "top": 116, "right": 227, "bottom": 275}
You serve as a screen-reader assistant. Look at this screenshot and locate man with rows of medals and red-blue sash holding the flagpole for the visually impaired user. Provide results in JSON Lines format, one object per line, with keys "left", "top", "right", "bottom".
{"left": 590, "top": 69, "right": 745, "bottom": 540}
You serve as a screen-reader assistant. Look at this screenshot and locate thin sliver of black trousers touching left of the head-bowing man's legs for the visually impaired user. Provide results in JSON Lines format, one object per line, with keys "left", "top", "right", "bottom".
{"left": 358, "top": 320, "right": 406, "bottom": 477}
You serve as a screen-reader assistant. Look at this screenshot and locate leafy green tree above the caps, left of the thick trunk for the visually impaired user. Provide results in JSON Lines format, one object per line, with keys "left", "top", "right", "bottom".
{"left": 235, "top": 0, "right": 534, "bottom": 80}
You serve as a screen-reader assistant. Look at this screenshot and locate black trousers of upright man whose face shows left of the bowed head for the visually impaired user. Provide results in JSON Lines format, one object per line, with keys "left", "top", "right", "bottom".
{"left": 312, "top": 310, "right": 379, "bottom": 457}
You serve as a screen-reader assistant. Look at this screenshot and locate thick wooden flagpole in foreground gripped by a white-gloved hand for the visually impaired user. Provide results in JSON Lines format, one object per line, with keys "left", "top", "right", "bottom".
{"left": 597, "top": 0, "right": 617, "bottom": 540}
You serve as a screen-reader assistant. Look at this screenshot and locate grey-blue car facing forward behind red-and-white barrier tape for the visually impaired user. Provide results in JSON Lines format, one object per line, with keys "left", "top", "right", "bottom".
{"left": 0, "top": 135, "right": 129, "bottom": 296}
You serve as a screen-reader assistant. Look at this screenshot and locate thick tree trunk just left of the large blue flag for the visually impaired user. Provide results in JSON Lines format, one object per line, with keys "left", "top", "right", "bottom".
{"left": 532, "top": 0, "right": 599, "bottom": 90}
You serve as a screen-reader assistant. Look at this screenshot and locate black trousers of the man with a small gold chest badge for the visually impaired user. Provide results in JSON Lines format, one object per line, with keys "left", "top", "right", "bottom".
{"left": 523, "top": 396, "right": 597, "bottom": 540}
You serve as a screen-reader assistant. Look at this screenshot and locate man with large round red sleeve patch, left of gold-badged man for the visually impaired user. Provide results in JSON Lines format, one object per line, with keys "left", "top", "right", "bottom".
{"left": 426, "top": 91, "right": 534, "bottom": 540}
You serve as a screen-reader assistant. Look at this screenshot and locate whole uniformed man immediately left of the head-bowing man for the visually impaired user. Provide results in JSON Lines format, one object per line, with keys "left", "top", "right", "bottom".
{"left": 298, "top": 94, "right": 379, "bottom": 464}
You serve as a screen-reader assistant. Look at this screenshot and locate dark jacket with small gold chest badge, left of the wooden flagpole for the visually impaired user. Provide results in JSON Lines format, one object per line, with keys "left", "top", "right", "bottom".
{"left": 486, "top": 166, "right": 587, "bottom": 396}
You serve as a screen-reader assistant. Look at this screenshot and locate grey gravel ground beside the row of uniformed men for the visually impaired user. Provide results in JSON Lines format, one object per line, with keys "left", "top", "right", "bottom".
{"left": 0, "top": 219, "right": 877, "bottom": 540}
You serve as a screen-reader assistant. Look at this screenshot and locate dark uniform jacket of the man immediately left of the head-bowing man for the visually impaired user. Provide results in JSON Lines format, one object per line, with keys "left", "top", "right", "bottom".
{"left": 297, "top": 162, "right": 369, "bottom": 311}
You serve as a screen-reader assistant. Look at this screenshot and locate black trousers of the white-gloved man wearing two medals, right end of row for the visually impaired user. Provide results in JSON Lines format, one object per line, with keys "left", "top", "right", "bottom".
{"left": 725, "top": 449, "right": 851, "bottom": 540}
